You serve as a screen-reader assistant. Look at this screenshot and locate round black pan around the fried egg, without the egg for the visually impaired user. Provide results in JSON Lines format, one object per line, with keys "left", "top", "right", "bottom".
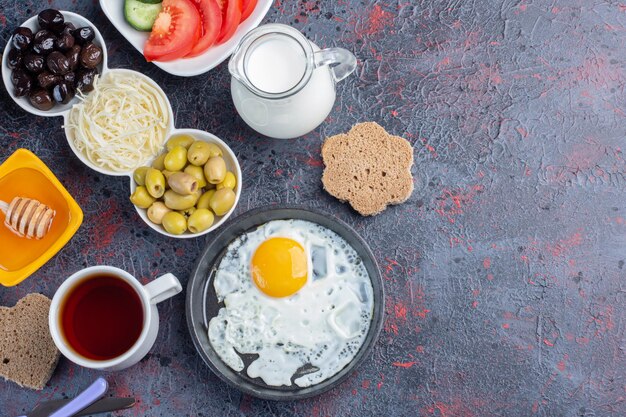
{"left": 186, "top": 206, "right": 385, "bottom": 400}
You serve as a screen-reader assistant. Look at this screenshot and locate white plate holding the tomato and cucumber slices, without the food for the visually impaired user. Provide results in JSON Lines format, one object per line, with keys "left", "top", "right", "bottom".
{"left": 100, "top": 0, "right": 273, "bottom": 77}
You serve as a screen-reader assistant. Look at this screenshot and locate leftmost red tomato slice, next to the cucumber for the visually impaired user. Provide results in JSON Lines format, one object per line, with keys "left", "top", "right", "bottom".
{"left": 143, "top": 0, "right": 201, "bottom": 61}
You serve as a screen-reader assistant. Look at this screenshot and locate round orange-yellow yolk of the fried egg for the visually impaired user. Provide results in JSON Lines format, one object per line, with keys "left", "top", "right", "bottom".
{"left": 252, "top": 237, "right": 307, "bottom": 297}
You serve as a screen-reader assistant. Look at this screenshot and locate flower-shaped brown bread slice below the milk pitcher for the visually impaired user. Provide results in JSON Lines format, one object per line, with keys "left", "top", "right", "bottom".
{"left": 322, "top": 122, "right": 413, "bottom": 216}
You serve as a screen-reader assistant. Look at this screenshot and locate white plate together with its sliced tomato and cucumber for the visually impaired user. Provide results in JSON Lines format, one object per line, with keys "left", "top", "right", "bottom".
{"left": 100, "top": 0, "right": 273, "bottom": 77}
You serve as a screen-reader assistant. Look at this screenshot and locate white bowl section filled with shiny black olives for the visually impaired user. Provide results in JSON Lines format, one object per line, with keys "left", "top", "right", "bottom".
{"left": 2, "top": 9, "right": 107, "bottom": 116}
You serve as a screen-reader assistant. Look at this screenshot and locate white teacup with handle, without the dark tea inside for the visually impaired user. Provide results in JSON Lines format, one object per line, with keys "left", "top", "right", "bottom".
{"left": 48, "top": 265, "right": 182, "bottom": 371}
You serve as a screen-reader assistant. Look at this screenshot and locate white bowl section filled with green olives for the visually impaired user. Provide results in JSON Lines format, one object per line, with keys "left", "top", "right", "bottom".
{"left": 130, "top": 129, "right": 241, "bottom": 239}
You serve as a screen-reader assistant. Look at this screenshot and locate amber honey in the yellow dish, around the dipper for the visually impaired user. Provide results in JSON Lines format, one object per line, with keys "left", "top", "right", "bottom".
{"left": 0, "top": 168, "right": 71, "bottom": 271}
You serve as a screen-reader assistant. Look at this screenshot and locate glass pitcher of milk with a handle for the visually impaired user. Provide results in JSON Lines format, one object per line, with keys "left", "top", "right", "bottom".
{"left": 228, "top": 23, "right": 356, "bottom": 139}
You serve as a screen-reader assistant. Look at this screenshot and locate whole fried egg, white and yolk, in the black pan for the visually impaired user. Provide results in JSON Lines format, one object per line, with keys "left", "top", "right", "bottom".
{"left": 209, "top": 220, "right": 374, "bottom": 387}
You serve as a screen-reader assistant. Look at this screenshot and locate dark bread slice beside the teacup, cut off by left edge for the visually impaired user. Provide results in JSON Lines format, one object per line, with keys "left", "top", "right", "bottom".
{"left": 0, "top": 294, "right": 60, "bottom": 390}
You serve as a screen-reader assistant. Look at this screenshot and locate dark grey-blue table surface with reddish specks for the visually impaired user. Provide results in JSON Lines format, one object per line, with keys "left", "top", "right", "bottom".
{"left": 0, "top": 0, "right": 626, "bottom": 417}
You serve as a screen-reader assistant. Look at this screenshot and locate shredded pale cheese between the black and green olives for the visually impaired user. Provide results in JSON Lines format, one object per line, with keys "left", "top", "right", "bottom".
{"left": 66, "top": 71, "right": 170, "bottom": 172}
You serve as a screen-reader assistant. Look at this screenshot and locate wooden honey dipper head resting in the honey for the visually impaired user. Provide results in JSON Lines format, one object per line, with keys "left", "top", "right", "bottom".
{"left": 0, "top": 197, "right": 56, "bottom": 239}
